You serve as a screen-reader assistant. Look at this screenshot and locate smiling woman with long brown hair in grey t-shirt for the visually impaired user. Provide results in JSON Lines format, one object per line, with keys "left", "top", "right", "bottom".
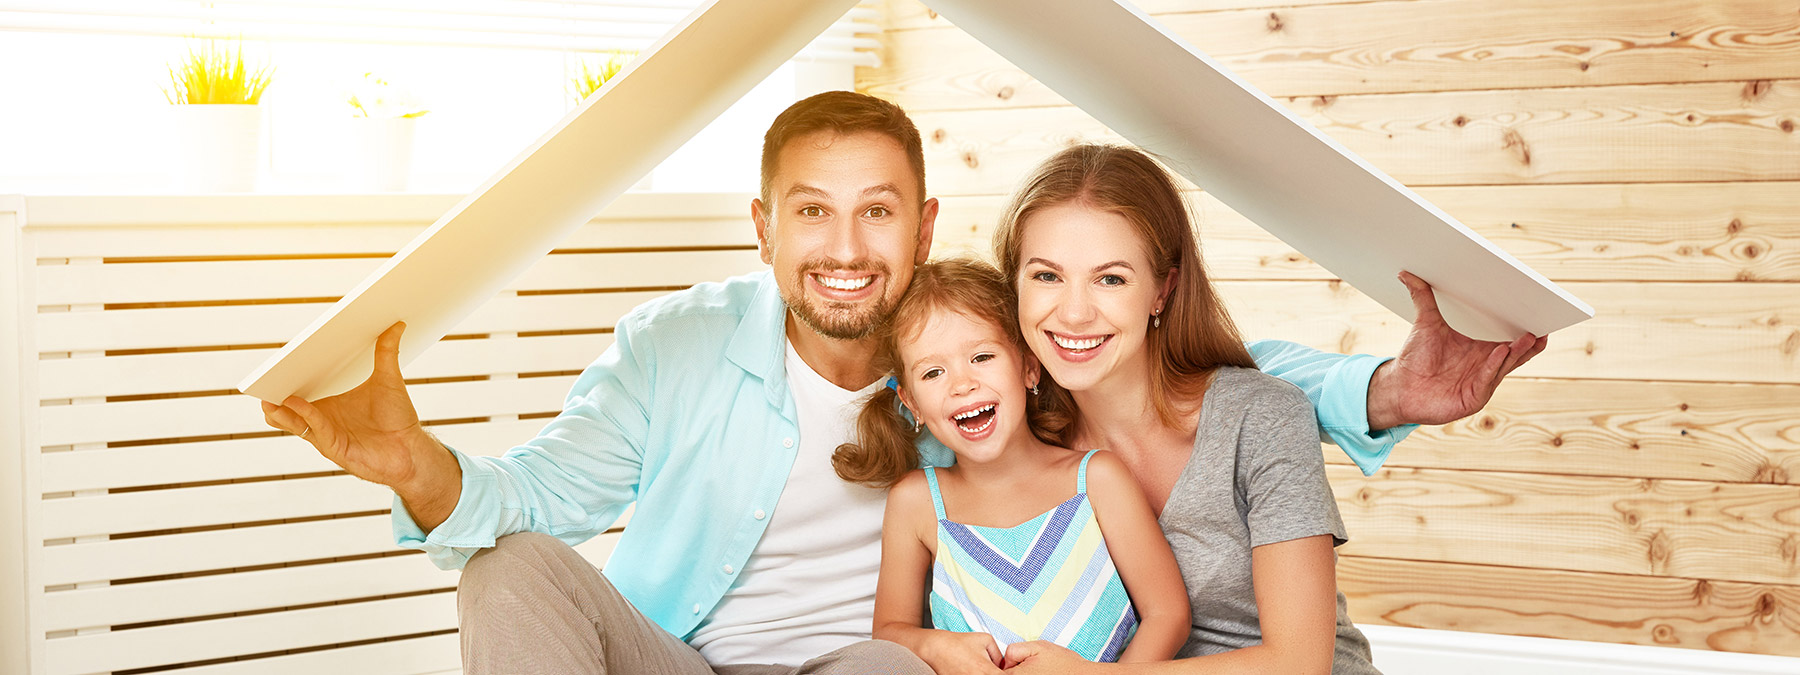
{"left": 994, "top": 146, "right": 1377, "bottom": 673}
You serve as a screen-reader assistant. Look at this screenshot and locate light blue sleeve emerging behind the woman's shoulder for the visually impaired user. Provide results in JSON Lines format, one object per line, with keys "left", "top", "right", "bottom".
{"left": 1247, "top": 340, "right": 1418, "bottom": 475}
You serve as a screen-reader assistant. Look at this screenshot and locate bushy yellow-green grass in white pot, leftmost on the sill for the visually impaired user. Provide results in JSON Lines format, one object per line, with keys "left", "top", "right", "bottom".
{"left": 162, "top": 41, "right": 274, "bottom": 193}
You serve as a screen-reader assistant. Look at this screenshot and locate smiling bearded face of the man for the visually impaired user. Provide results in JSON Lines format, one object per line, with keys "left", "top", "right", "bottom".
{"left": 751, "top": 131, "right": 938, "bottom": 340}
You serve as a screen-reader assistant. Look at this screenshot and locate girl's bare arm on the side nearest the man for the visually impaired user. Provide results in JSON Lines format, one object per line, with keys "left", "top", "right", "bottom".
{"left": 873, "top": 472, "right": 1001, "bottom": 675}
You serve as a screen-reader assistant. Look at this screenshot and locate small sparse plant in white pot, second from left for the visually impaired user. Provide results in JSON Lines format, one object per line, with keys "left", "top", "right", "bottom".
{"left": 344, "top": 72, "right": 430, "bottom": 191}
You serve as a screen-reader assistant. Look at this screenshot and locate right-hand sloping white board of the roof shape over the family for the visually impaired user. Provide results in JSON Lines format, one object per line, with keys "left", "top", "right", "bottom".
{"left": 927, "top": 0, "right": 1593, "bottom": 340}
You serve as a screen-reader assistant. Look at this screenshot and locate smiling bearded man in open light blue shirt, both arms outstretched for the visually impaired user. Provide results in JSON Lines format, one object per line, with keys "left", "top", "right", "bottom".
{"left": 265, "top": 92, "right": 1543, "bottom": 673}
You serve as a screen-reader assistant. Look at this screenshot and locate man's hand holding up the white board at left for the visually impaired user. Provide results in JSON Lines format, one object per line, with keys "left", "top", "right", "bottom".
{"left": 263, "top": 324, "right": 463, "bottom": 531}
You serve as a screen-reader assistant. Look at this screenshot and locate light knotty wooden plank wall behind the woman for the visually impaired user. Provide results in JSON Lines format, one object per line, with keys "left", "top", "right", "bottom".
{"left": 857, "top": 0, "right": 1800, "bottom": 655}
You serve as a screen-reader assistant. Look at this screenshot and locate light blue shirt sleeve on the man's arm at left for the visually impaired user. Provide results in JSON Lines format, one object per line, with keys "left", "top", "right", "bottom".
{"left": 392, "top": 317, "right": 652, "bottom": 569}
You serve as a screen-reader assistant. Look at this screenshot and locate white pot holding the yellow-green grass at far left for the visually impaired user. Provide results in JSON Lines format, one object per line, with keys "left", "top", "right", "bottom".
{"left": 169, "top": 104, "right": 268, "bottom": 193}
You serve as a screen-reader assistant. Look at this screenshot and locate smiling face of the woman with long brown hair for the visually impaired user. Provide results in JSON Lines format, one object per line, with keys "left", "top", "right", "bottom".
{"left": 1013, "top": 203, "right": 1166, "bottom": 392}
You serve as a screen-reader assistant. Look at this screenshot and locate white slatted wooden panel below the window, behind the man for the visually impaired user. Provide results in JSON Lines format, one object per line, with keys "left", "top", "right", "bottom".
{"left": 0, "top": 194, "right": 763, "bottom": 675}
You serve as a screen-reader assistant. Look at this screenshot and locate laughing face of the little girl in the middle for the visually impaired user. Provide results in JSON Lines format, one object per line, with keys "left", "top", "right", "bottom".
{"left": 898, "top": 310, "right": 1037, "bottom": 463}
